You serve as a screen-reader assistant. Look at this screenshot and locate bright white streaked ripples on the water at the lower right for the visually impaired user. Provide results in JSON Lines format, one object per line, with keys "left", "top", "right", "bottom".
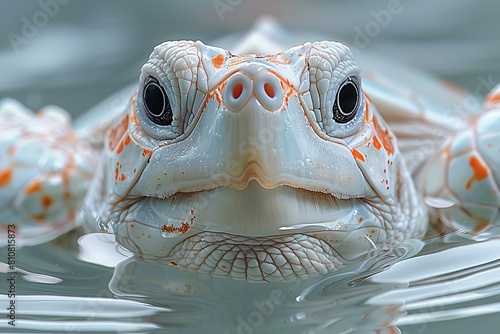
{"left": 369, "top": 239, "right": 500, "bottom": 329}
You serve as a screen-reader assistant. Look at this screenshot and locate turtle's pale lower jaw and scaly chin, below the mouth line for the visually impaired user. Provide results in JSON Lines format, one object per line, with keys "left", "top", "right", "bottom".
{"left": 116, "top": 182, "right": 383, "bottom": 282}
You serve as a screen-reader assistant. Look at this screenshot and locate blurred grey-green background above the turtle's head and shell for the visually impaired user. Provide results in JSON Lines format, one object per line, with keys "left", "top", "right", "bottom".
{"left": 0, "top": 0, "right": 500, "bottom": 115}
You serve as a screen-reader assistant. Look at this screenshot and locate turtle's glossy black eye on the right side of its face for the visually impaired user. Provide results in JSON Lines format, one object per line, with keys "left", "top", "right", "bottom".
{"left": 333, "top": 76, "right": 359, "bottom": 123}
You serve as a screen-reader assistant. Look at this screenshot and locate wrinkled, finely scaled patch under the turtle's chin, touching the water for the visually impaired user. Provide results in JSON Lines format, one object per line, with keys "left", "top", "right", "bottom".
{"left": 168, "top": 232, "right": 345, "bottom": 282}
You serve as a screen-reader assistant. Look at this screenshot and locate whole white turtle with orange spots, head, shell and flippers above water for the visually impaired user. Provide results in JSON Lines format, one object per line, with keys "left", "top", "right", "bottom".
{"left": 0, "top": 20, "right": 500, "bottom": 282}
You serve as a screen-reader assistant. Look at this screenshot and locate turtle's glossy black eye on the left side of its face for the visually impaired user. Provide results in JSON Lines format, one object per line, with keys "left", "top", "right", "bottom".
{"left": 142, "top": 76, "right": 173, "bottom": 125}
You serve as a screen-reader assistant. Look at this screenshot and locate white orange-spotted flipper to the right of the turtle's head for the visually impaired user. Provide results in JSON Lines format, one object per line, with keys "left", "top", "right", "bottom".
{"left": 417, "top": 85, "right": 500, "bottom": 239}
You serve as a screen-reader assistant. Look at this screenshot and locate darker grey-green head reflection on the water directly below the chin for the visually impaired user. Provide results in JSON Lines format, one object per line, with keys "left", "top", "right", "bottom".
{"left": 109, "top": 249, "right": 414, "bottom": 333}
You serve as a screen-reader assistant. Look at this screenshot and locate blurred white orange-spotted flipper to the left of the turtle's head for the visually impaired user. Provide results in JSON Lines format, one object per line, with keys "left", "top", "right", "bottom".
{"left": 0, "top": 99, "right": 97, "bottom": 246}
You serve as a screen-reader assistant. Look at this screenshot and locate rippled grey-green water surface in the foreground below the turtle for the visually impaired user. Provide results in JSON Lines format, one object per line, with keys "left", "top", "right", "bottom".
{"left": 0, "top": 231, "right": 500, "bottom": 334}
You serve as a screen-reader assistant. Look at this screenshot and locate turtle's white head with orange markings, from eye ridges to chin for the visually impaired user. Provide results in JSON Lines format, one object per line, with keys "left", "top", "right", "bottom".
{"left": 84, "top": 41, "right": 425, "bottom": 281}
